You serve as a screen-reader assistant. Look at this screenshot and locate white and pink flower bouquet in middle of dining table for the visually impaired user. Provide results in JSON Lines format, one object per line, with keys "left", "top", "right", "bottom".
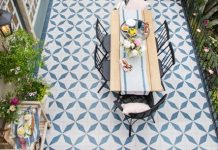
{"left": 123, "top": 38, "right": 142, "bottom": 57}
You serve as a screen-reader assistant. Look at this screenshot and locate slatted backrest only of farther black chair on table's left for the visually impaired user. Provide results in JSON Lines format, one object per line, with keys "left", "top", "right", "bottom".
{"left": 95, "top": 18, "right": 108, "bottom": 43}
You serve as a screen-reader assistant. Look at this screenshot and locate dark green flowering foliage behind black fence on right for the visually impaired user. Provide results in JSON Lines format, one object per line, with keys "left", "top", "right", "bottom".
{"left": 186, "top": 0, "right": 218, "bottom": 115}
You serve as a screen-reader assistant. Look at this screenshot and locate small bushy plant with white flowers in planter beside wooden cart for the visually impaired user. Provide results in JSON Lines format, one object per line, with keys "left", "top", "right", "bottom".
{"left": 16, "top": 78, "right": 49, "bottom": 101}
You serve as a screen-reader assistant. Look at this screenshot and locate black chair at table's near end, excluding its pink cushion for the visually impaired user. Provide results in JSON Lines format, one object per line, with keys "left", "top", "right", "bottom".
{"left": 114, "top": 93, "right": 167, "bottom": 137}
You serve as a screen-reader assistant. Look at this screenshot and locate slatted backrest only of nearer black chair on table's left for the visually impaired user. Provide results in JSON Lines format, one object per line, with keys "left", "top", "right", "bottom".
{"left": 94, "top": 44, "right": 106, "bottom": 76}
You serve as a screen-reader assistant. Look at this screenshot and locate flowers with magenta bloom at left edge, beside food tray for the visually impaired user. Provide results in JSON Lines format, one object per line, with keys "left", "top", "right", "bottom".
{"left": 0, "top": 93, "right": 20, "bottom": 123}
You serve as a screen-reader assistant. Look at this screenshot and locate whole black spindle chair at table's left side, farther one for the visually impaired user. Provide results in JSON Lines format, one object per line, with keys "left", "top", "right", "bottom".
{"left": 95, "top": 18, "right": 111, "bottom": 54}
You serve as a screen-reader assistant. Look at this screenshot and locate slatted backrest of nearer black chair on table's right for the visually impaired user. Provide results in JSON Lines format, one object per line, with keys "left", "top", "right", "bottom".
{"left": 158, "top": 42, "right": 175, "bottom": 77}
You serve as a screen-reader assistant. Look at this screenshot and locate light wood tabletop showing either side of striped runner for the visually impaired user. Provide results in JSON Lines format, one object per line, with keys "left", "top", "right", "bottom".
{"left": 110, "top": 10, "right": 163, "bottom": 92}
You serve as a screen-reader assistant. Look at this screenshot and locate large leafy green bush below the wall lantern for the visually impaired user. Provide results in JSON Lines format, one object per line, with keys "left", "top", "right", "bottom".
{"left": 0, "top": 30, "right": 42, "bottom": 84}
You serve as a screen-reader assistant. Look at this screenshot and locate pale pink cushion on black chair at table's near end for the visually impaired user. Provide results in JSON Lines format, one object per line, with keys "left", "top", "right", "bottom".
{"left": 121, "top": 103, "right": 150, "bottom": 115}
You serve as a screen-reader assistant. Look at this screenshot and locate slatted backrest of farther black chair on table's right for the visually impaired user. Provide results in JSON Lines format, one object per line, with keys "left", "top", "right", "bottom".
{"left": 155, "top": 20, "right": 170, "bottom": 52}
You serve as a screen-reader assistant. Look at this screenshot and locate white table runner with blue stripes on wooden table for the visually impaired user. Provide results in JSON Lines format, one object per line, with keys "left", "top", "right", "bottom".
{"left": 120, "top": 9, "right": 151, "bottom": 95}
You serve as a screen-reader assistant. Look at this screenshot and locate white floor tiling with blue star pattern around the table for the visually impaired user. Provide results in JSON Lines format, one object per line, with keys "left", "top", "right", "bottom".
{"left": 39, "top": 0, "right": 218, "bottom": 150}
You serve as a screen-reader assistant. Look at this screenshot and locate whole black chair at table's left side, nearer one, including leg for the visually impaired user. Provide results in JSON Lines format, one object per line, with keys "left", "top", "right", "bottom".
{"left": 94, "top": 45, "right": 110, "bottom": 93}
